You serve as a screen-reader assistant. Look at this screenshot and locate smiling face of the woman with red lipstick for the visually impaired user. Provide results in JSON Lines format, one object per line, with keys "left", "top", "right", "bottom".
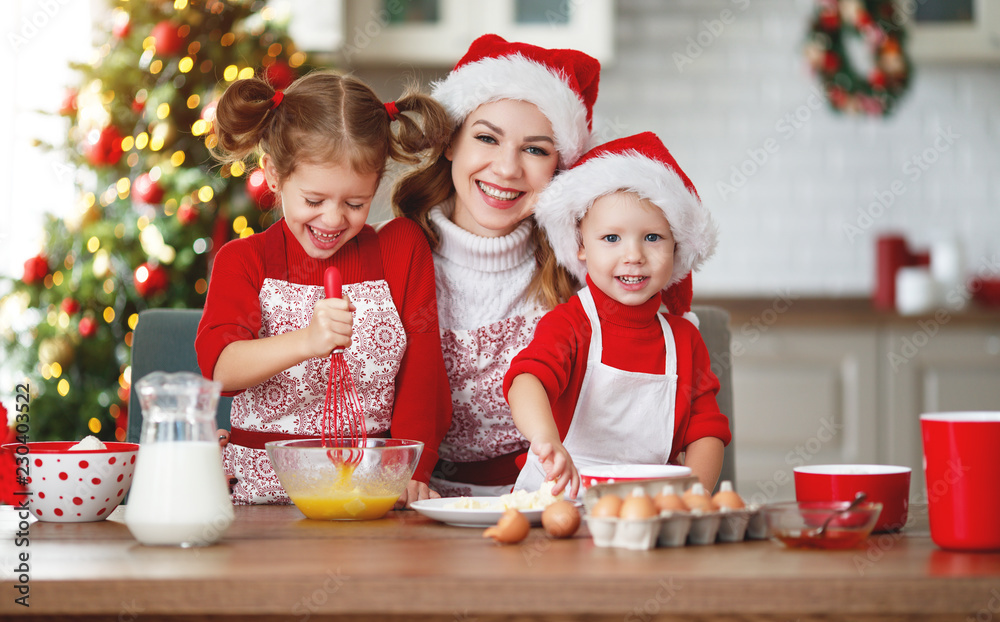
{"left": 445, "top": 99, "right": 559, "bottom": 237}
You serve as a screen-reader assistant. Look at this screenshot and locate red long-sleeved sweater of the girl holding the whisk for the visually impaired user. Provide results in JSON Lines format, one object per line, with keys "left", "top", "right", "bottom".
{"left": 195, "top": 218, "right": 451, "bottom": 482}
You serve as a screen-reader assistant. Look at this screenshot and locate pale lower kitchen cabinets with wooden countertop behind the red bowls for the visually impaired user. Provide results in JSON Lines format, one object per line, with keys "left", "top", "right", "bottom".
{"left": 696, "top": 299, "right": 1000, "bottom": 501}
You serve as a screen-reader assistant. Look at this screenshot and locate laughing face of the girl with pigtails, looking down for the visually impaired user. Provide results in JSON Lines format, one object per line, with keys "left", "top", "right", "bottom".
{"left": 263, "top": 155, "right": 379, "bottom": 259}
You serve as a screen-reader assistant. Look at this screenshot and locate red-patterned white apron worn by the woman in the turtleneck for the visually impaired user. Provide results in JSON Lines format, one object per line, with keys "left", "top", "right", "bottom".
{"left": 430, "top": 309, "right": 544, "bottom": 497}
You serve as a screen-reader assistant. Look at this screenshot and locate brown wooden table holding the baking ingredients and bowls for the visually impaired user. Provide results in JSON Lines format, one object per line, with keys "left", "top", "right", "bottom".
{"left": 0, "top": 506, "right": 1000, "bottom": 622}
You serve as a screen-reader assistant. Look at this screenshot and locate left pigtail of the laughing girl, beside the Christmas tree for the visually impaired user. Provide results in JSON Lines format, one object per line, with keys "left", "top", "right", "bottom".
{"left": 212, "top": 78, "right": 276, "bottom": 163}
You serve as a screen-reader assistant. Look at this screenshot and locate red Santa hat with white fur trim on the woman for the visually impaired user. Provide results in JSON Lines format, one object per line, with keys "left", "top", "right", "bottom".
{"left": 431, "top": 35, "right": 601, "bottom": 168}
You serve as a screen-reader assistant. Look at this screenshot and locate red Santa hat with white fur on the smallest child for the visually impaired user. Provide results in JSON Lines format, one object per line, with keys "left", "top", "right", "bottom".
{"left": 535, "top": 132, "right": 718, "bottom": 322}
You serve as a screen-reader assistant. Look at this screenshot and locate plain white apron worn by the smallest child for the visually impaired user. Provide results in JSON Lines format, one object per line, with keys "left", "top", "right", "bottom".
{"left": 514, "top": 287, "right": 677, "bottom": 498}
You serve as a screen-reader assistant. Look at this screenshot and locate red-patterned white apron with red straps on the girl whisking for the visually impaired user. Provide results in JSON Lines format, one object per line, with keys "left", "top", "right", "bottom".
{"left": 224, "top": 225, "right": 406, "bottom": 504}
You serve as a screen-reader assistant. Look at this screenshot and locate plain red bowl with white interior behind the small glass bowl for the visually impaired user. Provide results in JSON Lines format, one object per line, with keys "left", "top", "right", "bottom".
{"left": 793, "top": 464, "right": 910, "bottom": 532}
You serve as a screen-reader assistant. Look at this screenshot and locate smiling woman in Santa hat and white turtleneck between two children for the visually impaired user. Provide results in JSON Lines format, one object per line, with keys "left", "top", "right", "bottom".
{"left": 393, "top": 35, "right": 600, "bottom": 496}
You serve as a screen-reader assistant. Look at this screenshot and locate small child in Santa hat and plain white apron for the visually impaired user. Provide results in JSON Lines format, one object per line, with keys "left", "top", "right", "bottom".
{"left": 503, "top": 132, "right": 731, "bottom": 496}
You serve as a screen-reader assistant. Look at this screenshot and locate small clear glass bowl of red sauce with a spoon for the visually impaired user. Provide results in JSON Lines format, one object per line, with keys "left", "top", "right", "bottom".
{"left": 762, "top": 501, "right": 882, "bottom": 550}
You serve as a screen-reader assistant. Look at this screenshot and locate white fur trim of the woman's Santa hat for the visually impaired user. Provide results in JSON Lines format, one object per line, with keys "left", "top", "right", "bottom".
{"left": 431, "top": 54, "right": 590, "bottom": 168}
